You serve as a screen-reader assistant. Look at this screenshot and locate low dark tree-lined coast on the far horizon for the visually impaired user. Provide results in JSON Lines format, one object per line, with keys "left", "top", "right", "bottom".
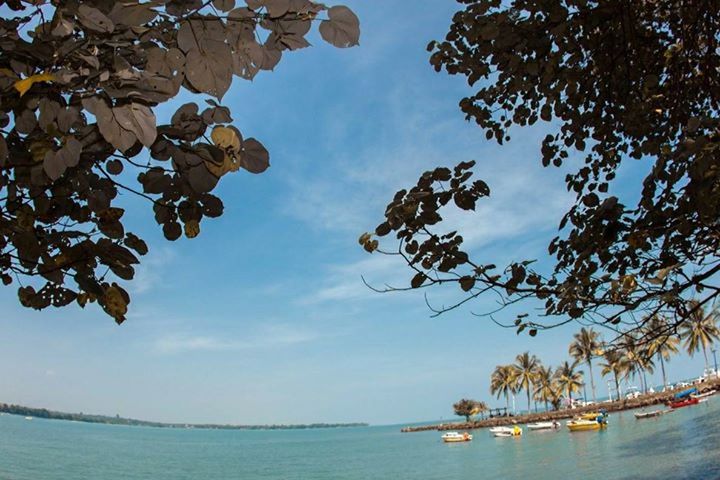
{"left": 0, "top": 403, "right": 369, "bottom": 430}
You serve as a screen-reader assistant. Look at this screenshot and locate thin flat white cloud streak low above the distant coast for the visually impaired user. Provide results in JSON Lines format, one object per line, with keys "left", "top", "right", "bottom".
{"left": 152, "top": 324, "right": 328, "bottom": 355}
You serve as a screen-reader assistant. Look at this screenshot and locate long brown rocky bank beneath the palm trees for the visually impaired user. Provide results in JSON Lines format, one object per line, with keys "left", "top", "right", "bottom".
{"left": 400, "top": 379, "right": 720, "bottom": 432}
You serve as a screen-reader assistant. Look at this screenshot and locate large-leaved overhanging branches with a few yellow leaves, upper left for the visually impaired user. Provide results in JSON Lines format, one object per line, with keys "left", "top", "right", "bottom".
{"left": 0, "top": 0, "right": 360, "bottom": 323}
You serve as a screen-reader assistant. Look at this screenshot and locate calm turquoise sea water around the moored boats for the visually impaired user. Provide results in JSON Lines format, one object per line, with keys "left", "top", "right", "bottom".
{"left": 0, "top": 395, "right": 720, "bottom": 480}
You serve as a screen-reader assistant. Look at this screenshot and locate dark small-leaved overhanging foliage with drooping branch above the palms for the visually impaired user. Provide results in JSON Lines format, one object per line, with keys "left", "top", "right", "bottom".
{"left": 360, "top": 0, "right": 720, "bottom": 341}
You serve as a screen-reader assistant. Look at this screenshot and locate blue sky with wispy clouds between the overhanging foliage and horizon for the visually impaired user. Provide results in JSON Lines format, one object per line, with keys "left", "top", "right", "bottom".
{"left": 0, "top": 0, "right": 703, "bottom": 423}
